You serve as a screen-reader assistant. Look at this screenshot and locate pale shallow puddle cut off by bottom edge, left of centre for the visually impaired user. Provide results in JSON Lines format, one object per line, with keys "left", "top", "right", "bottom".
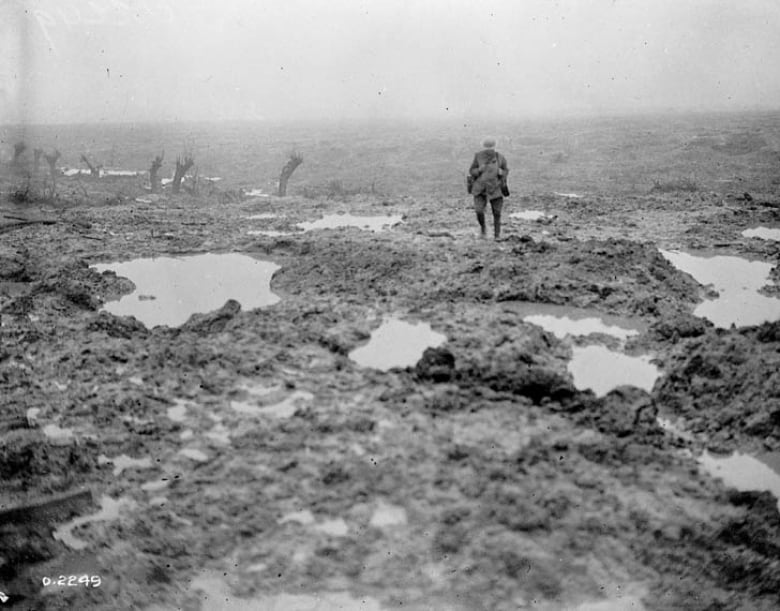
{"left": 146, "top": 571, "right": 382, "bottom": 611}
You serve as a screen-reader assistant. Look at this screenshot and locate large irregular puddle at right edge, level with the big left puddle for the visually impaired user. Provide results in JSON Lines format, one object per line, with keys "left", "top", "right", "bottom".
{"left": 661, "top": 250, "right": 780, "bottom": 329}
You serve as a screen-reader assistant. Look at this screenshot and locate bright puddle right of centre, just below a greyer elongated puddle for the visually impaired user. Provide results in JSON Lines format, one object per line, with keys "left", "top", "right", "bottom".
{"left": 568, "top": 346, "right": 660, "bottom": 397}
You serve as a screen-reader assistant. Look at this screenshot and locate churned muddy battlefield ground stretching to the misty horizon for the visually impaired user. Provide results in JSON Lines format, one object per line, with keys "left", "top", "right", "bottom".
{"left": 0, "top": 116, "right": 780, "bottom": 611}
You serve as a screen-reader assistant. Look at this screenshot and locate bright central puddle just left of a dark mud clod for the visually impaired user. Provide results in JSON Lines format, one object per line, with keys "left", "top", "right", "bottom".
{"left": 349, "top": 318, "right": 447, "bottom": 371}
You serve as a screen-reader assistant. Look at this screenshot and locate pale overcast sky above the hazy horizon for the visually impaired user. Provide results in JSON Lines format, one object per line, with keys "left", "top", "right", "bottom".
{"left": 0, "top": 0, "right": 780, "bottom": 123}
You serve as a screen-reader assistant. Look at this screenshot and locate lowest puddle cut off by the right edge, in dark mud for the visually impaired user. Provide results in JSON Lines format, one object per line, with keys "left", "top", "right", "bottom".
{"left": 698, "top": 450, "right": 780, "bottom": 511}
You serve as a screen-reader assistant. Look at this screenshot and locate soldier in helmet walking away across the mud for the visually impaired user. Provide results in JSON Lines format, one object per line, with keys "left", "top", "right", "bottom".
{"left": 469, "top": 138, "right": 509, "bottom": 240}
